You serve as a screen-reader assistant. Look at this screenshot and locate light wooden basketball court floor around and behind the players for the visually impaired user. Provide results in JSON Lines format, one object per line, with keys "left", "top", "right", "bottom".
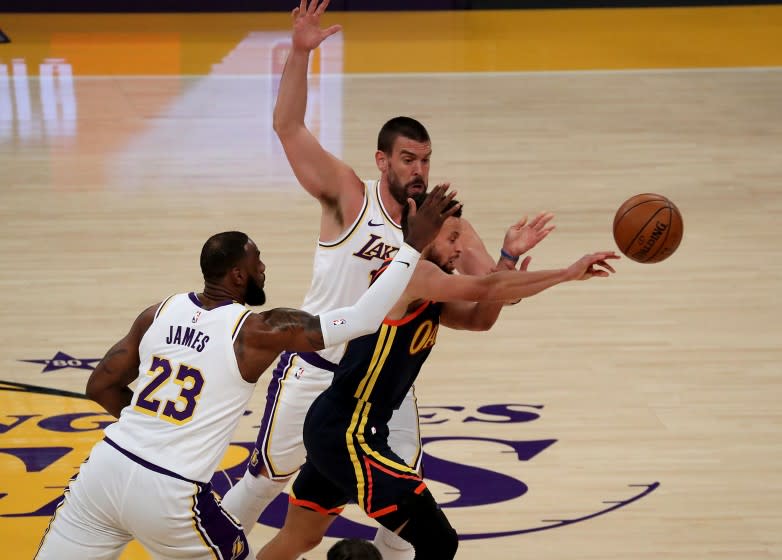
{"left": 0, "top": 7, "right": 782, "bottom": 560}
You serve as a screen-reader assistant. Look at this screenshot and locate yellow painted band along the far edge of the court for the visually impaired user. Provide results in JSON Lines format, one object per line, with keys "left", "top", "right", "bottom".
{"left": 0, "top": 6, "right": 782, "bottom": 75}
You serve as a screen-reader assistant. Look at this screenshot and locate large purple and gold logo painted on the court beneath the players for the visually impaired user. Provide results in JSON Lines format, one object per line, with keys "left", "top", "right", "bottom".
{"left": 0, "top": 384, "right": 659, "bottom": 540}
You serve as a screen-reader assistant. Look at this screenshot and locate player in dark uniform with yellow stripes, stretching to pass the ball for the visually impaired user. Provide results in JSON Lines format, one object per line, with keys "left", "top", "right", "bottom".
{"left": 258, "top": 196, "right": 619, "bottom": 560}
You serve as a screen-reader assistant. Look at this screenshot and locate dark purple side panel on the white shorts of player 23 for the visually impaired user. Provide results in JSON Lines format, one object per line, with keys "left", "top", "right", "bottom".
{"left": 193, "top": 487, "right": 250, "bottom": 560}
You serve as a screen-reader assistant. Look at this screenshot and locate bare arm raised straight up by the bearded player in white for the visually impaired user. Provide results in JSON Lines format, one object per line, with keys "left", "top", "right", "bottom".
{"left": 274, "top": 0, "right": 363, "bottom": 214}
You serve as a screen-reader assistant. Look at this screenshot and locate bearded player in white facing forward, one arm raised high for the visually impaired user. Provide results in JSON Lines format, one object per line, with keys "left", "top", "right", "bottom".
{"left": 217, "top": 0, "right": 553, "bottom": 560}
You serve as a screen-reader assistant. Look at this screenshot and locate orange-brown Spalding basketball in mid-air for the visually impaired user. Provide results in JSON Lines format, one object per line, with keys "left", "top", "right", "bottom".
{"left": 614, "top": 193, "right": 684, "bottom": 264}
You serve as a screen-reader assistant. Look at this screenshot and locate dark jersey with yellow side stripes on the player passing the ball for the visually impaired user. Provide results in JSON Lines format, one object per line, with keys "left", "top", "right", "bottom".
{"left": 326, "top": 301, "right": 442, "bottom": 423}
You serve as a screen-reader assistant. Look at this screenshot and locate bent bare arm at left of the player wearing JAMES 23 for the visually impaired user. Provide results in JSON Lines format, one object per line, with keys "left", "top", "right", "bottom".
{"left": 87, "top": 305, "right": 158, "bottom": 418}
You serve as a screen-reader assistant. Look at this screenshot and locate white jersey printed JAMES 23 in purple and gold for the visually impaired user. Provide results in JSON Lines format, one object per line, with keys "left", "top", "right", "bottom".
{"left": 105, "top": 293, "right": 255, "bottom": 482}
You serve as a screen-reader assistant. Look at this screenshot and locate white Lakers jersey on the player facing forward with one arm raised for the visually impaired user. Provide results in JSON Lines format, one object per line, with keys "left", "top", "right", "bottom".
{"left": 302, "top": 181, "right": 403, "bottom": 364}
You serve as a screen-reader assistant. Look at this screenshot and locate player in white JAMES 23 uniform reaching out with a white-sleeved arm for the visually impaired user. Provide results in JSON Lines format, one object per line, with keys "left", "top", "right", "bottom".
{"left": 36, "top": 187, "right": 451, "bottom": 560}
